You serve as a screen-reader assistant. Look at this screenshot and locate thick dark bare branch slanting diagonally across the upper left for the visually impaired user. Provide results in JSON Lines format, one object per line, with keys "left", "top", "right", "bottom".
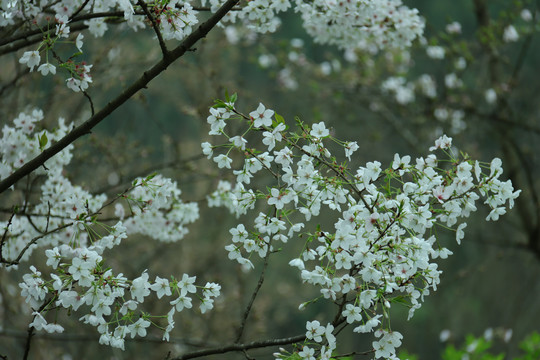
{"left": 0, "top": 0, "right": 240, "bottom": 193}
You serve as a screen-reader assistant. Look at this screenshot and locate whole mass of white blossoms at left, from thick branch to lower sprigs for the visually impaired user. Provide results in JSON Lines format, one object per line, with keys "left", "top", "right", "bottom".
{"left": 0, "top": 109, "right": 220, "bottom": 348}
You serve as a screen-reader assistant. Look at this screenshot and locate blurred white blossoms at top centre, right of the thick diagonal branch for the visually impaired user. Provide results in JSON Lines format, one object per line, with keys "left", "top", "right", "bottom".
{"left": 209, "top": 0, "right": 424, "bottom": 51}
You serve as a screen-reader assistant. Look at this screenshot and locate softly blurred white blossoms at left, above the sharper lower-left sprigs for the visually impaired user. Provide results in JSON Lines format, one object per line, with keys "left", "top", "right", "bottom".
{"left": 0, "top": 109, "right": 199, "bottom": 261}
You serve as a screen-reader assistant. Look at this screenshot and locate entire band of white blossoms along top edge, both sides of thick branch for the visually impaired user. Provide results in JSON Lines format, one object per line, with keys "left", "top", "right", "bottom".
{"left": 4, "top": 0, "right": 426, "bottom": 92}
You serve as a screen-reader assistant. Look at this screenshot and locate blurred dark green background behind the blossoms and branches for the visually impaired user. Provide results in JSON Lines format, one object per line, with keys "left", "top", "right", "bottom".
{"left": 0, "top": 0, "right": 540, "bottom": 360}
